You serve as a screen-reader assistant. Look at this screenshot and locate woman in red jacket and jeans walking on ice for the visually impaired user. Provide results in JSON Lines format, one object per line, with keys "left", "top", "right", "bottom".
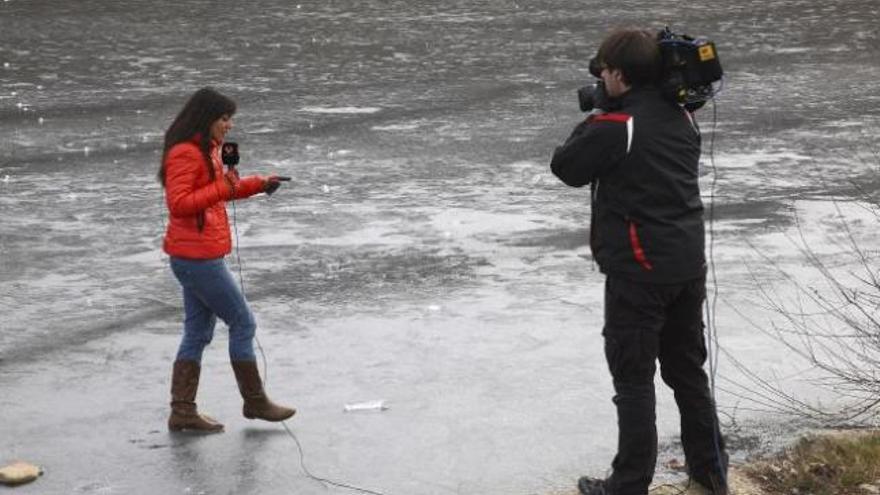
{"left": 158, "top": 88, "right": 296, "bottom": 432}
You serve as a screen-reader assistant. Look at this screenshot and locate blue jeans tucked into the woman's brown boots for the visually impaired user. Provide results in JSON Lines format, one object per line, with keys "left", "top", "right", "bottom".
{"left": 171, "top": 256, "right": 257, "bottom": 363}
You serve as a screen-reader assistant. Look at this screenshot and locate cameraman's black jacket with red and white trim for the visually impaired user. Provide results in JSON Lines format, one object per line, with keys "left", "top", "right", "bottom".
{"left": 550, "top": 88, "right": 706, "bottom": 283}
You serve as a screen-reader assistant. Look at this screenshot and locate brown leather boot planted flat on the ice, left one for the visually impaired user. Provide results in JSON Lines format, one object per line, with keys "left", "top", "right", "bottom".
{"left": 168, "top": 360, "right": 223, "bottom": 433}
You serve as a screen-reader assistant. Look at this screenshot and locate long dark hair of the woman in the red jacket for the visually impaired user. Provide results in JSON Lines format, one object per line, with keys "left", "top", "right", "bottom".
{"left": 156, "top": 88, "right": 235, "bottom": 187}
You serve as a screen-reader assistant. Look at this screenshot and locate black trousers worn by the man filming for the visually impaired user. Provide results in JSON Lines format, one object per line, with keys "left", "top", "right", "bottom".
{"left": 602, "top": 275, "right": 727, "bottom": 495}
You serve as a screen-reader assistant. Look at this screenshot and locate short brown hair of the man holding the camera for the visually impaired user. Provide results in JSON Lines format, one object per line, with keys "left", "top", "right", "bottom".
{"left": 596, "top": 28, "right": 663, "bottom": 87}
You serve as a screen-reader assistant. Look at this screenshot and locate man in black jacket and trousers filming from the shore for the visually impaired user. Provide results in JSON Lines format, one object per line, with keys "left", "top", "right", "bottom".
{"left": 550, "top": 29, "right": 727, "bottom": 495}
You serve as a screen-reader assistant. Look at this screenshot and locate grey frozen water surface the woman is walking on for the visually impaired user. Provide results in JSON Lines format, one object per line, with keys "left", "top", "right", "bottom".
{"left": 0, "top": 0, "right": 880, "bottom": 495}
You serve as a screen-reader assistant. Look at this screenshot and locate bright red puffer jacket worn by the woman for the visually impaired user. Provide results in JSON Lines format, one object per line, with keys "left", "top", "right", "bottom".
{"left": 163, "top": 141, "right": 265, "bottom": 259}
